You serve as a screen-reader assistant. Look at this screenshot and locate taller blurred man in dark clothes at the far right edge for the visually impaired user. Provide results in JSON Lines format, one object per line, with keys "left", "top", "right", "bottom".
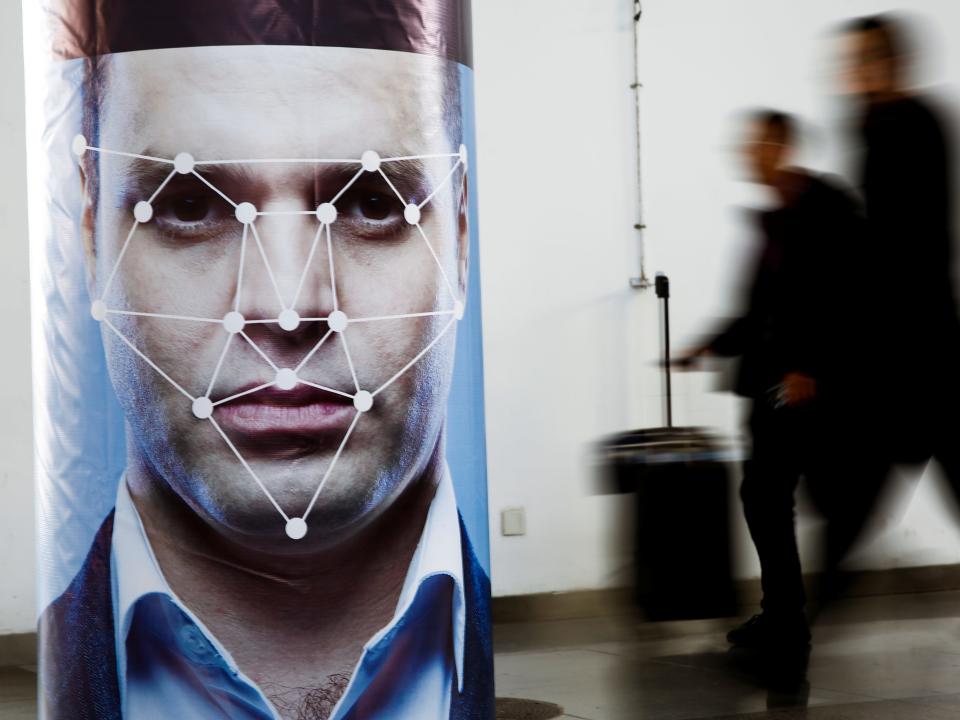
{"left": 812, "top": 15, "right": 960, "bottom": 599}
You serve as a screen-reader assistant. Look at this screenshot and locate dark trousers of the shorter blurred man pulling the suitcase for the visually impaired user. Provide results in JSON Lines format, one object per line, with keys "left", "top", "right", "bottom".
{"left": 740, "top": 398, "right": 817, "bottom": 614}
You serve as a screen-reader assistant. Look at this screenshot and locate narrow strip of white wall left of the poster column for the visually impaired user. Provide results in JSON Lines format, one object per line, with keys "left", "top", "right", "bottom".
{"left": 0, "top": 2, "right": 35, "bottom": 634}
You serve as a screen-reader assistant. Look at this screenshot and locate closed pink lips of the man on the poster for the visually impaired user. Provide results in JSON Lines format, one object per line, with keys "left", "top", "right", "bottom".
{"left": 214, "top": 384, "right": 356, "bottom": 440}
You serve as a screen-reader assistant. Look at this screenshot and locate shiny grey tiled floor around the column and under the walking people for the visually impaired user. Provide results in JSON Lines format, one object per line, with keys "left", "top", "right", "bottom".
{"left": 0, "top": 592, "right": 960, "bottom": 720}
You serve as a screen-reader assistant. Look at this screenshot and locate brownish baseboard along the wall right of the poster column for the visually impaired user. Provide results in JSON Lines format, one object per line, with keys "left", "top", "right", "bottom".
{"left": 492, "top": 565, "right": 960, "bottom": 623}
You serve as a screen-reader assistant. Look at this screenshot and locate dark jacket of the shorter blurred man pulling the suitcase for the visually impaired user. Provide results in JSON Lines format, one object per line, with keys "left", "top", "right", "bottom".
{"left": 709, "top": 175, "right": 864, "bottom": 399}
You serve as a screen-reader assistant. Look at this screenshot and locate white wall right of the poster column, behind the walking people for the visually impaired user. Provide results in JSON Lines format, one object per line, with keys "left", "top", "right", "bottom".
{"left": 474, "top": 0, "right": 960, "bottom": 595}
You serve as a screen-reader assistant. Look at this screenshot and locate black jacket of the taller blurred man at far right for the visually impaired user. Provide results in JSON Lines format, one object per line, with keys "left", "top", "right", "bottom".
{"left": 861, "top": 97, "right": 960, "bottom": 462}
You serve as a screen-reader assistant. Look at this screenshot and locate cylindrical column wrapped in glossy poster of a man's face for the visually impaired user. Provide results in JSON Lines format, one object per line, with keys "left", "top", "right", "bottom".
{"left": 28, "top": 0, "right": 493, "bottom": 720}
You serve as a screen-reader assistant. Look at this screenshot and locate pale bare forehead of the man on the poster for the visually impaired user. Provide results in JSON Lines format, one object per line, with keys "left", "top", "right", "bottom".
{"left": 101, "top": 46, "right": 445, "bottom": 159}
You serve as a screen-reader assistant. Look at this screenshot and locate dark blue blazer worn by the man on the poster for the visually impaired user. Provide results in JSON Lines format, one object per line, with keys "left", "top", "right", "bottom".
{"left": 39, "top": 512, "right": 494, "bottom": 720}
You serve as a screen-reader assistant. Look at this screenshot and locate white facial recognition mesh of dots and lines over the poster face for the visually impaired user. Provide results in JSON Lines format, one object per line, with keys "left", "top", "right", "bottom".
{"left": 71, "top": 135, "right": 467, "bottom": 540}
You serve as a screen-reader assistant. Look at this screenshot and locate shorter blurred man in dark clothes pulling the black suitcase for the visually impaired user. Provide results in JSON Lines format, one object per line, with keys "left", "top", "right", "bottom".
{"left": 687, "top": 111, "right": 860, "bottom": 650}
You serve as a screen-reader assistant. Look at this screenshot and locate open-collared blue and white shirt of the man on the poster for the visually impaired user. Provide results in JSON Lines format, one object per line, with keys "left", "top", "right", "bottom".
{"left": 111, "top": 472, "right": 465, "bottom": 720}
